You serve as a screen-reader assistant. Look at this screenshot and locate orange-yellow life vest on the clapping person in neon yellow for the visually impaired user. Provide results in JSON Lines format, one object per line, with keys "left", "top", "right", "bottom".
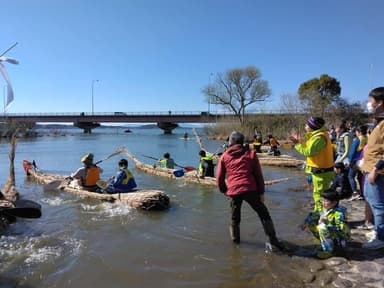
{"left": 307, "top": 130, "right": 334, "bottom": 168}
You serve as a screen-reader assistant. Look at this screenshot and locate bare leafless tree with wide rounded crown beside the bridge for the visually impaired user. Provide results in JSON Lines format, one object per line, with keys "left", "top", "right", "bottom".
{"left": 203, "top": 66, "right": 271, "bottom": 124}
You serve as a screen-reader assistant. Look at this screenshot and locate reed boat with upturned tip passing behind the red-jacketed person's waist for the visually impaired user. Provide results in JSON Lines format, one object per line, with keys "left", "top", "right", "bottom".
{"left": 121, "top": 150, "right": 289, "bottom": 186}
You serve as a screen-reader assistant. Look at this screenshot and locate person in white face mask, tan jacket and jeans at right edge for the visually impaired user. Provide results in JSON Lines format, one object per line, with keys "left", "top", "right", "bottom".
{"left": 362, "top": 87, "right": 384, "bottom": 249}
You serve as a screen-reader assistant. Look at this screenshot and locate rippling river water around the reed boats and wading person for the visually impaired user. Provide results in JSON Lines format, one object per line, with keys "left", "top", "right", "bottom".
{"left": 0, "top": 128, "right": 316, "bottom": 288}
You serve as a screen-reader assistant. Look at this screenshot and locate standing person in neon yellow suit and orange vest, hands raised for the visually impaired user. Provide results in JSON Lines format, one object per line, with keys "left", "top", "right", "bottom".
{"left": 289, "top": 117, "right": 335, "bottom": 212}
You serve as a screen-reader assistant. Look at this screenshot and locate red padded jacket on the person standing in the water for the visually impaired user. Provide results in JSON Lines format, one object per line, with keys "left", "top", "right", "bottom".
{"left": 216, "top": 144, "right": 265, "bottom": 196}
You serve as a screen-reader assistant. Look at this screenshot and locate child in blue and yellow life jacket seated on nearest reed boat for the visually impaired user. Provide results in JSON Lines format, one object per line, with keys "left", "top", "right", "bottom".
{"left": 105, "top": 159, "right": 137, "bottom": 194}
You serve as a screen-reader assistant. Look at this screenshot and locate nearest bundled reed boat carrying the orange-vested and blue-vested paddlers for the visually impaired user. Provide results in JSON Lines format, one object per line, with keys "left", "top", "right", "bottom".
{"left": 23, "top": 160, "right": 170, "bottom": 210}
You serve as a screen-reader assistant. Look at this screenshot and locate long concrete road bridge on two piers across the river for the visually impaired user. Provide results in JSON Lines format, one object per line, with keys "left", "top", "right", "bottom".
{"left": 0, "top": 111, "right": 228, "bottom": 134}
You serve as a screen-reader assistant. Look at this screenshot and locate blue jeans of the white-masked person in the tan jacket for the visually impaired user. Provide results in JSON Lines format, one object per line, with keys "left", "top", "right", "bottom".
{"left": 364, "top": 174, "right": 384, "bottom": 241}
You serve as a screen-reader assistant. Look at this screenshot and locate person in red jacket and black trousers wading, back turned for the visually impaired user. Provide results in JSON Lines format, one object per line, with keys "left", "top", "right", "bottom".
{"left": 216, "top": 131, "right": 285, "bottom": 250}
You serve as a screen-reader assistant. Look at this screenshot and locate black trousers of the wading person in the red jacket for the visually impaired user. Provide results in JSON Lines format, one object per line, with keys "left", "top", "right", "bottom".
{"left": 229, "top": 191, "right": 271, "bottom": 225}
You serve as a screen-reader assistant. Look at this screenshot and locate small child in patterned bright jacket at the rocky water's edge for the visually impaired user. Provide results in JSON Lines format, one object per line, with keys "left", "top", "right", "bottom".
{"left": 301, "top": 189, "right": 350, "bottom": 259}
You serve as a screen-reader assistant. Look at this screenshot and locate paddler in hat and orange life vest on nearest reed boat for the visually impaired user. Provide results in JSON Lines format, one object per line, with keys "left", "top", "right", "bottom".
{"left": 70, "top": 153, "right": 103, "bottom": 191}
